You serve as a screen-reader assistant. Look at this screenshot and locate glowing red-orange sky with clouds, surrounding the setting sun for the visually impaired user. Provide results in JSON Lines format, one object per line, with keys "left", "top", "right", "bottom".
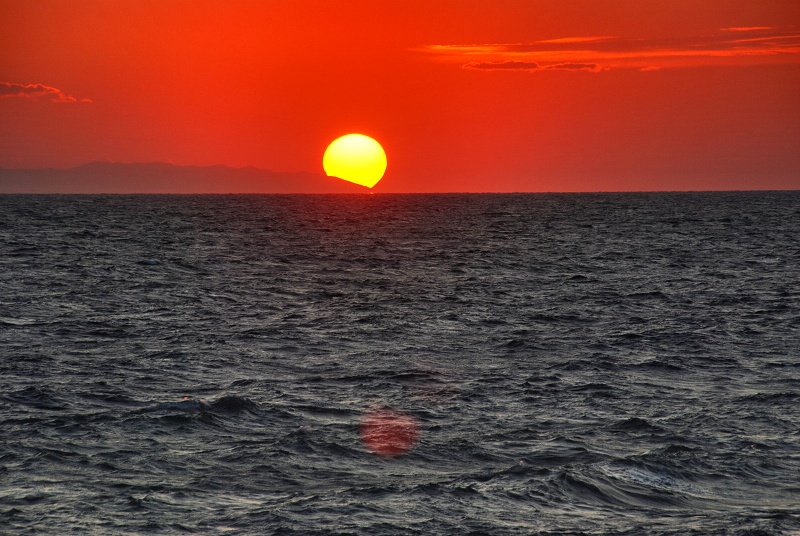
{"left": 0, "top": 0, "right": 800, "bottom": 192}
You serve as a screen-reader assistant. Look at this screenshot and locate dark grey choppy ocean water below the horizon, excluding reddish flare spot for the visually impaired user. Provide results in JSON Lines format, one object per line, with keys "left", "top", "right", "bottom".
{"left": 0, "top": 192, "right": 800, "bottom": 535}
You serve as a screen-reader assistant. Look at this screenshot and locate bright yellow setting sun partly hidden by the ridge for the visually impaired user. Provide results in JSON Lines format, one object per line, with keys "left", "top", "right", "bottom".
{"left": 322, "top": 134, "right": 386, "bottom": 188}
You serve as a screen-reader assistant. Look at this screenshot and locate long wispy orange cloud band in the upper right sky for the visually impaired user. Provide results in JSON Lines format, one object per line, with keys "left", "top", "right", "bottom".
{"left": 420, "top": 26, "right": 800, "bottom": 72}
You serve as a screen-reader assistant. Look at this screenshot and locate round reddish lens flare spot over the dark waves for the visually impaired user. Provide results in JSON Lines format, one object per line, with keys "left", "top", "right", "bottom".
{"left": 360, "top": 407, "right": 420, "bottom": 457}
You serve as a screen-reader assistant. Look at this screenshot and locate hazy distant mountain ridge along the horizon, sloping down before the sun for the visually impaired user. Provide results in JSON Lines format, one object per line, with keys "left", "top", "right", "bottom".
{"left": 0, "top": 162, "right": 369, "bottom": 194}
